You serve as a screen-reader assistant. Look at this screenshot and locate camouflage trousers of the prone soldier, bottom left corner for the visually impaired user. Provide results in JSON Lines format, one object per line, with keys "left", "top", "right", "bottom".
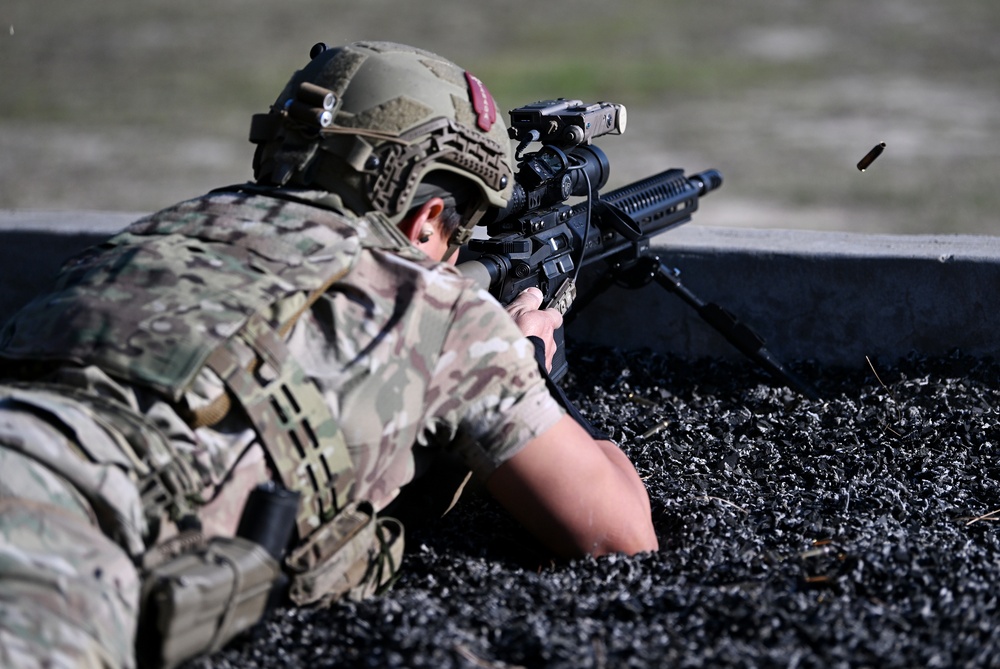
{"left": 0, "top": 396, "right": 142, "bottom": 668}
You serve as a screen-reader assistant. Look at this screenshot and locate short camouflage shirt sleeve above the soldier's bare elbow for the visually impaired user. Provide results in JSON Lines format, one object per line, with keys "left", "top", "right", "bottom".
{"left": 418, "top": 287, "right": 564, "bottom": 479}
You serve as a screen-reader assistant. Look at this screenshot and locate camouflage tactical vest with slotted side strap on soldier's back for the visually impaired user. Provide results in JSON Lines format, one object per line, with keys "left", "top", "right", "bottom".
{"left": 0, "top": 187, "right": 420, "bottom": 664}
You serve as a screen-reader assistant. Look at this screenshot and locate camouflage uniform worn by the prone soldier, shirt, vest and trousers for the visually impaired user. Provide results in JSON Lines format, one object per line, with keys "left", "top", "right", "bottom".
{"left": 0, "top": 189, "right": 562, "bottom": 667}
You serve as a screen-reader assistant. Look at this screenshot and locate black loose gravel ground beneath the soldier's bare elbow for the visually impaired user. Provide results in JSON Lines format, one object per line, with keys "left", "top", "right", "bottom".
{"left": 191, "top": 345, "right": 1000, "bottom": 669}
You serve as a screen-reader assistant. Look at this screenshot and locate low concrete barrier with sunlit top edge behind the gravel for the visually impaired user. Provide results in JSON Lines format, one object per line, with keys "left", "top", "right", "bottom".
{"left": 0, "top": 211, "right": 1000, "bottom": 367}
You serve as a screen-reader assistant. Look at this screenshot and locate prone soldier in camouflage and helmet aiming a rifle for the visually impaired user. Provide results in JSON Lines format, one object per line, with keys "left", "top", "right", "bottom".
{"left": 0, "top": 43, "right": 657, "bottom": 667}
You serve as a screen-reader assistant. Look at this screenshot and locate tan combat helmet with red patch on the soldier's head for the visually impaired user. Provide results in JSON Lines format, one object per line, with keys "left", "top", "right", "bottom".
{"left": 250, "top": 42, "right": 513, "bottom": 243}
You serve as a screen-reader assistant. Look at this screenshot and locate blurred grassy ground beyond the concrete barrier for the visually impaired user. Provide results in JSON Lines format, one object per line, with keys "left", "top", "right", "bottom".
{"left": 0, "top": 0, "right": 1000, "bottom": 234}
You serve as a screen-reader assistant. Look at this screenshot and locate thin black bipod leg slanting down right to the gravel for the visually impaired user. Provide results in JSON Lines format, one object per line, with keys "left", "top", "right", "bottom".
{"left": 633, "top": 256, "right": 819, "bottom": 400}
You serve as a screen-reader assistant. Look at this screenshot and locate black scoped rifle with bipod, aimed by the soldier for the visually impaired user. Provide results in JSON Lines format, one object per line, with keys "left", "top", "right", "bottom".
{"left": 458, "top": 98, "right": 818, "bottom": 399}
